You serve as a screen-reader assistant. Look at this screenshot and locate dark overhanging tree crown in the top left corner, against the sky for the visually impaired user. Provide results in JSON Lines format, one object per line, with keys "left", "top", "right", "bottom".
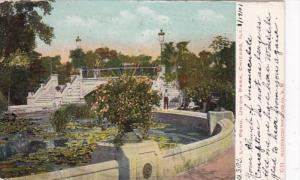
{"left": 0, "top": 1, "right": 54, "bottom": 59}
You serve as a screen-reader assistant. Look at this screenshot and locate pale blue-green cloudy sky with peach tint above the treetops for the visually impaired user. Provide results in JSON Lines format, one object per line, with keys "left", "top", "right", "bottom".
{"left": 37, "top": 0, "right": 235, "bottom": 61}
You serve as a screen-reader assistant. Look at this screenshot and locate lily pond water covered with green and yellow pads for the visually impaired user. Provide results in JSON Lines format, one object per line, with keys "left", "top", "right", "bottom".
{"left": 0, "top": 118, "right": 206, "bottom": 178}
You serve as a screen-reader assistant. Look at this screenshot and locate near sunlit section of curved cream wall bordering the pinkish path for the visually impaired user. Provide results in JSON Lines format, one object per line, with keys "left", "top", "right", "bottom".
{"left": 160, "top": 119, "right": 234, "bottom": 177}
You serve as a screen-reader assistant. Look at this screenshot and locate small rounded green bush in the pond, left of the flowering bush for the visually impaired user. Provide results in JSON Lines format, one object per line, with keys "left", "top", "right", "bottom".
{"left": 49, "top": 106, "right": 72, "bottom": 132}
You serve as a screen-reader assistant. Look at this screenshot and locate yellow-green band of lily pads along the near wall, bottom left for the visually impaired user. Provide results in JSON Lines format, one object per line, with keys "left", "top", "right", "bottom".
{"left": 0, "top": 142, "right": 96, "bottom": 177}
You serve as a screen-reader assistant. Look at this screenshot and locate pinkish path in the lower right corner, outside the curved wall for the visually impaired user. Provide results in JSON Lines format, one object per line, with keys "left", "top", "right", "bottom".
{"left": 173, "top": 147, "right": 234, "bottom": 180}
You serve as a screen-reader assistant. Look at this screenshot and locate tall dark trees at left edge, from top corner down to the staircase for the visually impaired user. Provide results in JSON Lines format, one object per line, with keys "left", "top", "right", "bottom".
{"left": 0, "top": 0, "right": 54, "bottom": 104}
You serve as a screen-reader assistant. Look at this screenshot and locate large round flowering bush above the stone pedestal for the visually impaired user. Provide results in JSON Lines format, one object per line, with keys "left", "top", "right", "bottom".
{"left": 93, "top": 74, "right": 160, "bottom": 143}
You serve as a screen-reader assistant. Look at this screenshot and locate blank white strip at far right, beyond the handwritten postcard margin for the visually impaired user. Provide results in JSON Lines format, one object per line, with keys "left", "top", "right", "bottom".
{"left": 285, "top": 0, "right": 300, "bottom": 180}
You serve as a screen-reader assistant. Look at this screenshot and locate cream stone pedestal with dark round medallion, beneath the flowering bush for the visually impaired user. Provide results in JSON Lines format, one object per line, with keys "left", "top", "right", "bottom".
{"left": 92, "top": 141, "right": 161, "bottom": 180}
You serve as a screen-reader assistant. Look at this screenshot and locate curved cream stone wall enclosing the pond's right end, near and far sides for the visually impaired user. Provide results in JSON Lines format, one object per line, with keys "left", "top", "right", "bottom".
{"left": 155, "top": 110, "right": 234, "bottom": 179}
